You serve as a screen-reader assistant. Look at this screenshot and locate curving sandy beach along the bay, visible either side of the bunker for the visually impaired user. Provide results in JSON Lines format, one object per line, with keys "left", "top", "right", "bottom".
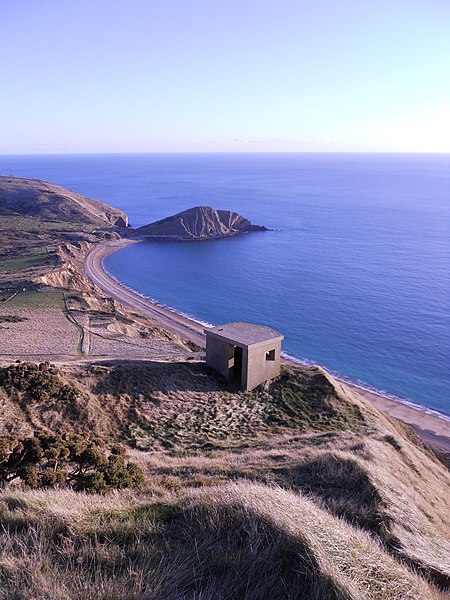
{"left": 84, "top": 240, "right": 450, "bottom": 452}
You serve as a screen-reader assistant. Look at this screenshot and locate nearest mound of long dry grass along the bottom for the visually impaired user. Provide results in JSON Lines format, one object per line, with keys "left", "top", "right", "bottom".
{"left": 0, "top": 482, "right": 442, "bottom": 600}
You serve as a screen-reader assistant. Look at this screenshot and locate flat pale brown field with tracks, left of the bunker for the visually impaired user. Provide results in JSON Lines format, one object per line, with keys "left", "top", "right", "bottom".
{"left": 0, "top": 288, "right": 193, "bottom": 361}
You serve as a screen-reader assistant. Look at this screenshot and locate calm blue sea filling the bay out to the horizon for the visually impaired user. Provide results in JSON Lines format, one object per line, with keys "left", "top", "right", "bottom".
{"left": 0, "top": 154, "right": 450, "bottom": 414}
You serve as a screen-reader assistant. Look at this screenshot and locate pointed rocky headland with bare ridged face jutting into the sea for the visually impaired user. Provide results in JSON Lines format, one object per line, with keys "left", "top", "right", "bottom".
{"left": 135, "top": 206, "right": 267, "bottom": 240}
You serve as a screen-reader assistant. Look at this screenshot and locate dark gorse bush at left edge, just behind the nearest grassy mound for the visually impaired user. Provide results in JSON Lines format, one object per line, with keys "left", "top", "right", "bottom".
{"left": 0, "top": 433, "right": 145, "bottom": 493}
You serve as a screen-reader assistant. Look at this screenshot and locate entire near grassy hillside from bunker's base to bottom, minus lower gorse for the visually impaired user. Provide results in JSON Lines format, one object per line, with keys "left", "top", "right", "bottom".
{"left": 0, "top": 362, "right": 450, "bottom": 600}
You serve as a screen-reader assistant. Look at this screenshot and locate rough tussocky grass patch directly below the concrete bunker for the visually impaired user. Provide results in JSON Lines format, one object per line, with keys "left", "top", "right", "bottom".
{"left": 77, "top": 362, "right": 366, "bottom": 450}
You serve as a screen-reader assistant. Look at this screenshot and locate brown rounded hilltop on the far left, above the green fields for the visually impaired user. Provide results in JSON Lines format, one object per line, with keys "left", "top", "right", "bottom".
{"left": 0, "top": 177, "right": 128, "bottom": 227}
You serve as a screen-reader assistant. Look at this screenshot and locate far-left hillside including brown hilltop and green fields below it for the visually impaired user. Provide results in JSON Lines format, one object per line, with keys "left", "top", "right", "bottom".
{"left": 0, "top": 176, "right": 128, "bottom": 292}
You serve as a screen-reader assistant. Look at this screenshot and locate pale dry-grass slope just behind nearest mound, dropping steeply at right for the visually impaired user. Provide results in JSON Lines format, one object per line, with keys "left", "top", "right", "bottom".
{"left": 127, "top": 432, "right": 450, "bottom": 587}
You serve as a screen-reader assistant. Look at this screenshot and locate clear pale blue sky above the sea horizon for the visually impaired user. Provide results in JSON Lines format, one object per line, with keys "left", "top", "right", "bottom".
{"left": 0, "top": 0, "right": 450, "bottom": 154}
